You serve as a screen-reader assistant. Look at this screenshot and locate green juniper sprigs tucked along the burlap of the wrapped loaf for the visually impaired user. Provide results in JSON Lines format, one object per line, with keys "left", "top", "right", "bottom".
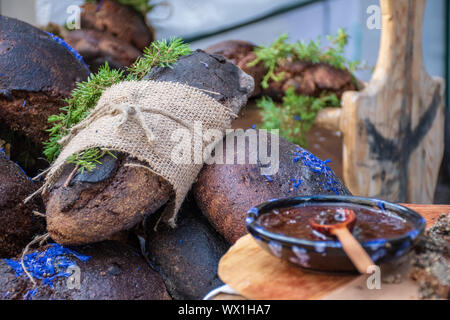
{"left": 44, "top": 38, "right": 191, "bottom": 171}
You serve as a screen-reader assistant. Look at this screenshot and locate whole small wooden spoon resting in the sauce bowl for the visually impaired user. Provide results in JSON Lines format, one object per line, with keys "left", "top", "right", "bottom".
{"left": 309, "top": 209, "right": 375, "bottom": 274}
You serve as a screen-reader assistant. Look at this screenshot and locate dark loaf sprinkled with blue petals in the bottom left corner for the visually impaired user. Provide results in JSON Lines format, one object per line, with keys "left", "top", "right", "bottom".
{"left": 0, "top": 241, "right": 170, "bottom": 300}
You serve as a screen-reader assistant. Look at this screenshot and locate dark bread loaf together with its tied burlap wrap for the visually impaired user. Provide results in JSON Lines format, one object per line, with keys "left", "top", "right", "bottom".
{"left": 44, "top": 51, "right": 253, "bottom": 244}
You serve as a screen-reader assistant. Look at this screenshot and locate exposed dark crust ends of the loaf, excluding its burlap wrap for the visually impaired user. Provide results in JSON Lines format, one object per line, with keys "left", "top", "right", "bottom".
{"left": 45, "top": 51, "right": 253, "bottom": 244}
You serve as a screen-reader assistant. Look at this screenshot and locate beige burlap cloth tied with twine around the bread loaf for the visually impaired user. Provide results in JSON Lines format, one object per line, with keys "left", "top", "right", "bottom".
{"left": 26, "top": 81, "right": 236, "bottom": 226}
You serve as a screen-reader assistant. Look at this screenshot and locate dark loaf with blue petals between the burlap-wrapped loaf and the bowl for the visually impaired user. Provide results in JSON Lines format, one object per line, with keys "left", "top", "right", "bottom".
{"left": 193, "top": 131, "right": 350, "bottom": 243}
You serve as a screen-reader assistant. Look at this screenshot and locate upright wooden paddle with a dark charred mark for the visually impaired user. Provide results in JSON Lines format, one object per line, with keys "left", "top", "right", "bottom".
{"left": 339, "top": 0, "right": 445, "bottom": 203}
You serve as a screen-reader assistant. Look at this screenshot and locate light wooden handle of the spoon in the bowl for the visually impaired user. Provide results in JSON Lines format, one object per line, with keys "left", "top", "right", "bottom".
{"left": 333, "top": 228, "right": 375, "bottom": 274}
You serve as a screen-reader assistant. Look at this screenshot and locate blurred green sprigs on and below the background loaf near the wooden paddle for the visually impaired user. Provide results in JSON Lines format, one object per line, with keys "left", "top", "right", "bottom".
{"left": 253, "top": 29, "right": 360, "bottom": 147}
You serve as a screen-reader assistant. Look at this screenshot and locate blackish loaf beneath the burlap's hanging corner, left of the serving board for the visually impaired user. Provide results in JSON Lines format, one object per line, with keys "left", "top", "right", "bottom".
{"left": 146, "top": 200, "right": 229, "bottom": 299}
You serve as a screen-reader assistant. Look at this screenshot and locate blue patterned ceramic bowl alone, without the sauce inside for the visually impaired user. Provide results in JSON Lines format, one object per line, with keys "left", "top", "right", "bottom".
{"left": 245, "top": 196, "right": 426, "bottom": 273}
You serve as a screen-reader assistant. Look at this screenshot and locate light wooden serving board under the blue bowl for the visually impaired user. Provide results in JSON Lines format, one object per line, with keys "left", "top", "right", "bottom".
{"left": 218, "top": 205, "right": 450, "bottom": 300}
